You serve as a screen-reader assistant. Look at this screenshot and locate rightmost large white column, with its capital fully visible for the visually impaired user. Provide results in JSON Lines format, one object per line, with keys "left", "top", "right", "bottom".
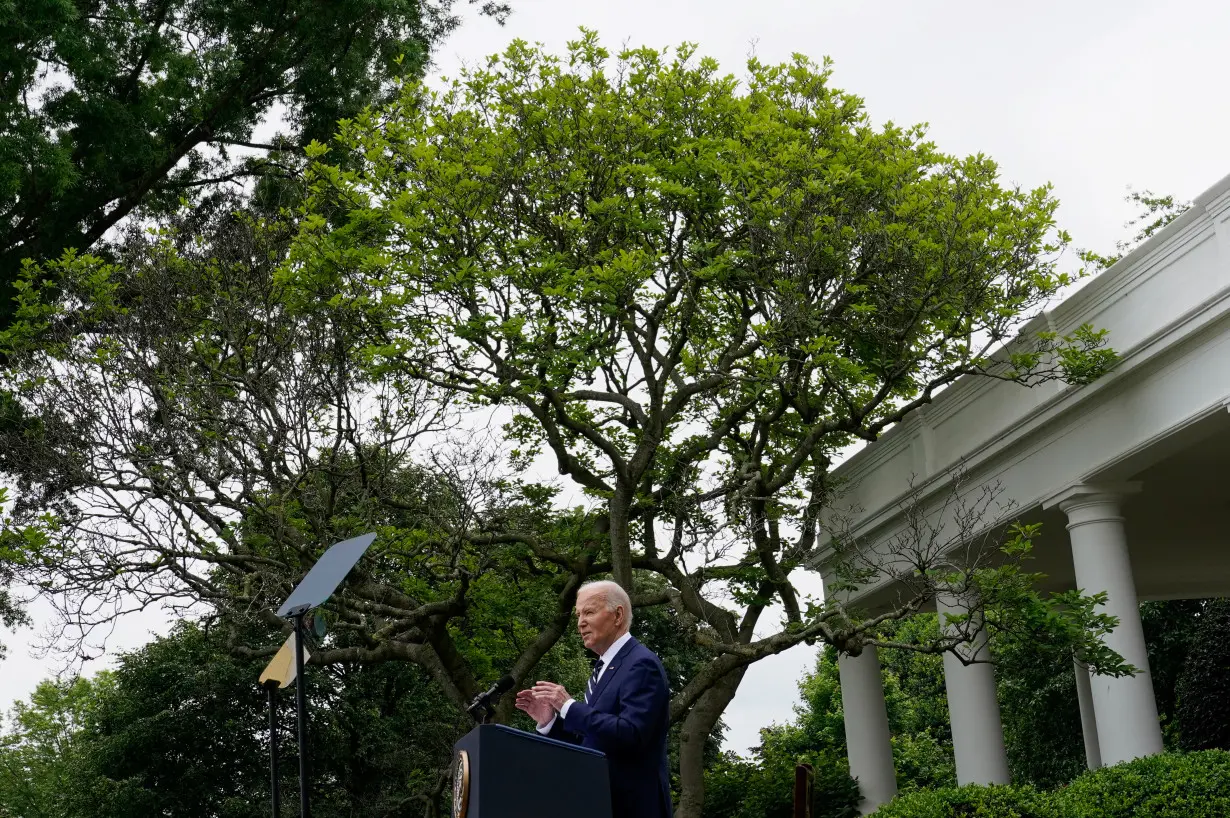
{"left": 1057, "top": 486, "right": 1162, "bottom": 765}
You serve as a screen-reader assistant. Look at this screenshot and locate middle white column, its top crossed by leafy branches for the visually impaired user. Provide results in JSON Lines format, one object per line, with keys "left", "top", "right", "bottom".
{"left": 935, "top": 594, "right": 1010, "bottom": 786}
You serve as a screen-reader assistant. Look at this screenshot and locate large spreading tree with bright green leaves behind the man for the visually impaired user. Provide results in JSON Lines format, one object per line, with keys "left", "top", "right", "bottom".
{"left": 293, "top": 32, "right": 1126, "bottom": 816}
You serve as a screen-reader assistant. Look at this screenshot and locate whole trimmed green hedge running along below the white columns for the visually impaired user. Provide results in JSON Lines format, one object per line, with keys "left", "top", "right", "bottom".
{"left": 873, "top": 750, "right": 1230, "bottom": 818}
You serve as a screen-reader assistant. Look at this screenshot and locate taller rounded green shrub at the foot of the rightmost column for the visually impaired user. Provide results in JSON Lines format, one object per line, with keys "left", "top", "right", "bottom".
{"left": 1055, "top": 750, "right": 1230, "bottom": 818}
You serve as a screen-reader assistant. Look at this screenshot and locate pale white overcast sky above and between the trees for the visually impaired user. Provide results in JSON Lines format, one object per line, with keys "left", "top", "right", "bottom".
{"left": 0, "top": 0, "right": 1230, "bottom": 752}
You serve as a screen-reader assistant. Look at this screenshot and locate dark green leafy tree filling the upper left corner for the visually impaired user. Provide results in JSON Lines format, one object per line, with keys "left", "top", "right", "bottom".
{"left": 0, "top": 0, "right": 508, "bottom": 326}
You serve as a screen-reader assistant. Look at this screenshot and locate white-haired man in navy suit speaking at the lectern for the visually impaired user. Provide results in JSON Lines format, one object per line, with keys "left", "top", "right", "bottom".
{"left": 517, "top": 582, "right": 670, "bottom": 818}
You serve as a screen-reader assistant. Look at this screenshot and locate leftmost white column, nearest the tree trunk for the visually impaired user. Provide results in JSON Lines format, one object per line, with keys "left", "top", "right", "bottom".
{"left": 838, "top": 645, "right": 897, "bottom": 816}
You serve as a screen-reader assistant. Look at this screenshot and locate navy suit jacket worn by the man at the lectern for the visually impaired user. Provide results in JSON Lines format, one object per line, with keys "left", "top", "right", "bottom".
{"left": 550, "top": 638, "right": 670, "bottom": 818}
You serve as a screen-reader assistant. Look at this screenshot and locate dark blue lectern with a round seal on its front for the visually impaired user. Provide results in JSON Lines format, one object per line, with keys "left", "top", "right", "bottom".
{"left": 453, "top": 725, "right": 611, "bottom": 818}
